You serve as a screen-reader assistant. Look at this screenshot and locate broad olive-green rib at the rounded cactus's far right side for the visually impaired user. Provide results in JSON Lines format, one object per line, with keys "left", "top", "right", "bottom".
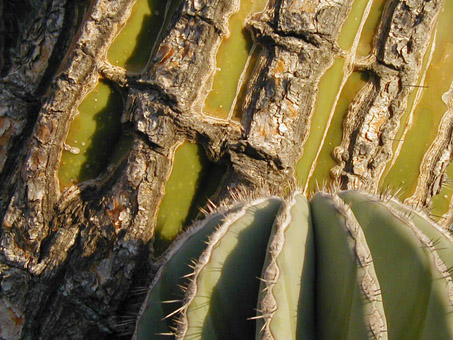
{"left": 340, "top": 191, "right": 453, "bottom": 340}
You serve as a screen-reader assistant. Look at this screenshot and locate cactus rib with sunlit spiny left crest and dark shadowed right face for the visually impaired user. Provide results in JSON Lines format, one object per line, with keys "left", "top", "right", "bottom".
{"left": 176, "top": 198, "right": 282, "bottom": 340}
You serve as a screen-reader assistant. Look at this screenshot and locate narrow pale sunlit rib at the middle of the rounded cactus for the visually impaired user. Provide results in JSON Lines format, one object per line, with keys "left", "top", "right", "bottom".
{"left": 256, "top": 194, "right": 315, "bottom": 340}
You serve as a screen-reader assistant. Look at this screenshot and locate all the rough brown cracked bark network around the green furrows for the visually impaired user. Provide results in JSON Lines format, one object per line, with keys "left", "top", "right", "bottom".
{"left": 0, "top": 0, "right": 441, "bottom": 339}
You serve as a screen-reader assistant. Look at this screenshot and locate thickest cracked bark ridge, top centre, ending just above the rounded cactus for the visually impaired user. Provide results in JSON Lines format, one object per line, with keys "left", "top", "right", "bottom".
{"left": 226, "top": 0, "right": 352, "bottom": 192}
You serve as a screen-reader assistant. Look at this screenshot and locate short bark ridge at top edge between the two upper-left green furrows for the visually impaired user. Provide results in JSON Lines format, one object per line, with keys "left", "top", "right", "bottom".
{"left": 138, "top": 0, "right": 239, "bottom": 112}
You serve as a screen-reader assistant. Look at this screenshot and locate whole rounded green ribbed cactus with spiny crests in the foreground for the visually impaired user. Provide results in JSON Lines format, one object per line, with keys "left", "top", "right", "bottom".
{"left": 134, "top": 191, "right": 453, "bottom": 340}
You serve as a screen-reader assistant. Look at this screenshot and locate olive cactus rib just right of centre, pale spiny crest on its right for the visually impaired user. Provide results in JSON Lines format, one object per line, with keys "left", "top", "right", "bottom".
{"left": 311, "top": 193, "right": 388, "bottom": 340}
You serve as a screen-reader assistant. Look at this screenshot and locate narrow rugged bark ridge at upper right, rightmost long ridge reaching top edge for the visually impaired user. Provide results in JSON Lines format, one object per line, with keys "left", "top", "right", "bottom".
{"left": 332, "top": 0, "right": 442, "bottom": 191}
